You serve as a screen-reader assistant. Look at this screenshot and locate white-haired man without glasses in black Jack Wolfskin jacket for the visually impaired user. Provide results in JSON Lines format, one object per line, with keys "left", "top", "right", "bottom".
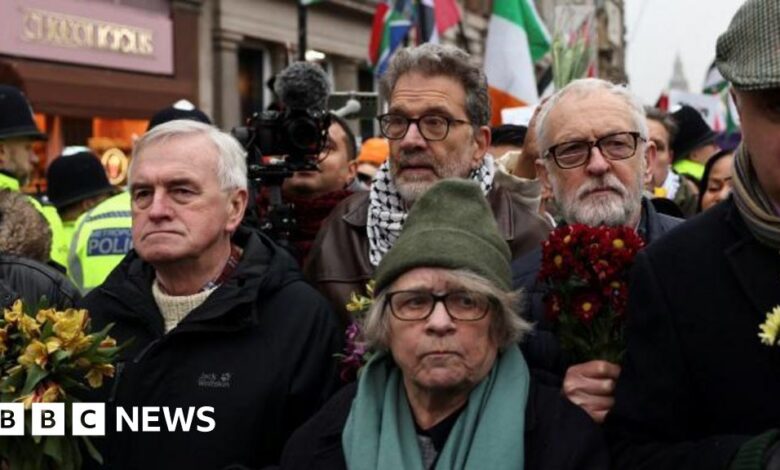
{"left": 83, "top": 120, "right": 340, "bottom": 469}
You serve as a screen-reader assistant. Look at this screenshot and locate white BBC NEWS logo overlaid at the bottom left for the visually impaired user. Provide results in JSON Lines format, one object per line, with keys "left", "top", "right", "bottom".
{"left": 0, "top": 403, "right": 217, "bottom": 436}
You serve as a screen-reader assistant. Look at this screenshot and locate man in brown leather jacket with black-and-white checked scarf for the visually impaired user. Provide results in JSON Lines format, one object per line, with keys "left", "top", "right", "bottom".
{"left": 304, "top": 44, "right": 550, "bottom": 320}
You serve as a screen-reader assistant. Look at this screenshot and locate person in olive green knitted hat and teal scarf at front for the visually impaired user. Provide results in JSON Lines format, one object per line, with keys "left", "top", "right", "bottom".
{"left": 282, "top": 180, "right": 609, "bottom": 470}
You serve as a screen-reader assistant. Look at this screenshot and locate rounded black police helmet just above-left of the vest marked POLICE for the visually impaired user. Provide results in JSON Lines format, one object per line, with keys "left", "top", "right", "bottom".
{"left": 46, "top": 152, "right": 114, "bottom": 209}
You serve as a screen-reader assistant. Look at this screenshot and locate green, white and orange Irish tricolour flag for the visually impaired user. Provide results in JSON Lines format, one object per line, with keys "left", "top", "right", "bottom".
{"left": 485, "top": 0, "right": 550, "bottom": 125}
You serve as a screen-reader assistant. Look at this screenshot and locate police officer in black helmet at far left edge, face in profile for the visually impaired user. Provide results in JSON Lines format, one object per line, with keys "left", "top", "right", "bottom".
{"left": 0, "top": 85, "right": 65, "bottom": 259}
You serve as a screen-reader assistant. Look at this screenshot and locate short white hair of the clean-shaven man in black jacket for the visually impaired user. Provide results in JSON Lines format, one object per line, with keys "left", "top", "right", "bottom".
{"left": 128, "top": 119, "right": 248, "bottom": 191}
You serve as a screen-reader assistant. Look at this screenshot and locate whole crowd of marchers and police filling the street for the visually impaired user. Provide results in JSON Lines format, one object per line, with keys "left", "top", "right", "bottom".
{"left": 0, "top": 0, "right": 780, "bottom": 470}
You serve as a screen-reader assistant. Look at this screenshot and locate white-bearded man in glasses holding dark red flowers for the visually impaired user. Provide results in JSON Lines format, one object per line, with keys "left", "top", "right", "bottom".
{"left": 512, "top": 79, "right": 681, "bottom": 423}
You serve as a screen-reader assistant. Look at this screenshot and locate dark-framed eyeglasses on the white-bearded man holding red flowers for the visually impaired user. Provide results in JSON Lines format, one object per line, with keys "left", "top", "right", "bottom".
{"left": 547, "top": 132, "right": 646, "bottom": 170}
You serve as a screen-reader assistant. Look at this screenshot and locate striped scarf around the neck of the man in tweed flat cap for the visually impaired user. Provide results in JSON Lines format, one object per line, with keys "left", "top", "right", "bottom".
{"left": 733, "top": 145, "right": 780, "bottom": 250}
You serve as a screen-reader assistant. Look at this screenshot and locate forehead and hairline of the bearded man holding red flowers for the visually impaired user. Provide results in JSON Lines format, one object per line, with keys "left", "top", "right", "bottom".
{"left": 543, "top": 90, "right": 639, "bottom": 147}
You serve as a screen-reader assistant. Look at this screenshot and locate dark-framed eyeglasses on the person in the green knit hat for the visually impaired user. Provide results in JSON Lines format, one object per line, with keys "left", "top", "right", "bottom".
{"left": 385, "top": 290, "right": 493, "bottom": 321}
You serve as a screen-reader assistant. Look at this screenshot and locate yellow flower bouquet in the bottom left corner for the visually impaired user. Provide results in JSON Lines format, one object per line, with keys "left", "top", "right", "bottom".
{"left": 0, "top": 300, "right": 125, "bottom": 470}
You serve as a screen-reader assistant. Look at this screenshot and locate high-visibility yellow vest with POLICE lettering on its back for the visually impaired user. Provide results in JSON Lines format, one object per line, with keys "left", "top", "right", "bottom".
{"left": 68, "top": 191, "right": 133, "bottom": 293}
